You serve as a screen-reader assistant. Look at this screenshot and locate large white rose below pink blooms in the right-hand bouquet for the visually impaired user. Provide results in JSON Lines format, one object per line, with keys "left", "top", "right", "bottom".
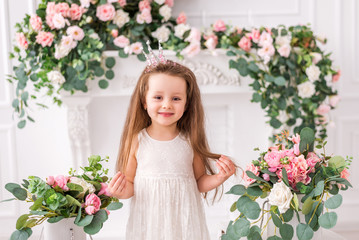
{"left": 268, "top": 181, "right": 293, "bottom": 213}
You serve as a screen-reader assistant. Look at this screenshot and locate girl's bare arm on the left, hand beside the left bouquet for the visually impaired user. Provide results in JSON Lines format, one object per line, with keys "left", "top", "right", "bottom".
{"left": 108, "top": 136, "right": 138, "bottom": 199}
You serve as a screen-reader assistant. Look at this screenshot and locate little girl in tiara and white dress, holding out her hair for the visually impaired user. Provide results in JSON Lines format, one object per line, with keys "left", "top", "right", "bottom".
{"left": 108, "top": 44, "right": 235, "bottom": 240}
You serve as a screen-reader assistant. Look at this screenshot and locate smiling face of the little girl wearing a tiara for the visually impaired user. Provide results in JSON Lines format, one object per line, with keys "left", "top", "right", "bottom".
{"left": 144, "top": 73, "right": 187, "bottom": 127}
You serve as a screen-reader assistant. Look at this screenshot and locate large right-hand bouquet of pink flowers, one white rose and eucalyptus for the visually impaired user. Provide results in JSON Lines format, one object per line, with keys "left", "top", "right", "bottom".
{"left": 222, "top": 128, "right": 352, "bottom": 240}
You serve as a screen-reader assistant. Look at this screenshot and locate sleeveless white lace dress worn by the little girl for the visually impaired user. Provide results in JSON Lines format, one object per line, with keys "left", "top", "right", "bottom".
{"left": 126, "top": 129, "right": 210, "bottom": 240}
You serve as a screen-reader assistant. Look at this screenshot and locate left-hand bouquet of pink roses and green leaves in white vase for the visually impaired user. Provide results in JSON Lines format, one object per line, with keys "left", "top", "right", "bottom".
{"left": 3, "top": 155, "right": 122, "bottom": 239}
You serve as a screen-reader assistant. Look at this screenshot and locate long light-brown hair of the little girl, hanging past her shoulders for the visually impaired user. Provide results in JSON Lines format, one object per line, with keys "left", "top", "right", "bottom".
{"left": 116, "top": 60, "right": 220, "bottom": 201}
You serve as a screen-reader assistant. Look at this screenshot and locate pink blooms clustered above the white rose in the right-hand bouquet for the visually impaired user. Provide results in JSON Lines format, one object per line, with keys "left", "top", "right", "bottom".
{"left": 244, "top": 134, "right": 321, "bottom": 189}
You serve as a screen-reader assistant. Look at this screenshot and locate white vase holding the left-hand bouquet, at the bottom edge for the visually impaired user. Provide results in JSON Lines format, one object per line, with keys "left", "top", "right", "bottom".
{"left": 43, "top": 218, "right": 86, "bottom": 240}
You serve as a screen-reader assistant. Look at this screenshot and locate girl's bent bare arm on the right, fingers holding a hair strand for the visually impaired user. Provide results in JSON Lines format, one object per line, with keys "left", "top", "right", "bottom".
{"left": 193, "top": 155, "right": 236, "bottom": 192}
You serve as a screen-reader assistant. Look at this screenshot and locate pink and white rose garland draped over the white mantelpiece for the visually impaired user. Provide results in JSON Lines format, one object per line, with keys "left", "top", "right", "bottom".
{"left": 8, "top": 0, "right": 340, "bottom": 141}
